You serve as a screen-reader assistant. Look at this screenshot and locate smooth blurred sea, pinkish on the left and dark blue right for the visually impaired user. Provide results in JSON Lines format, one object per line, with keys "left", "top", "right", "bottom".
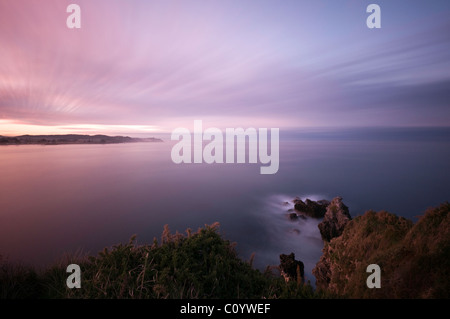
{"left": 0, "top": 127, "right": 450, "bottom": 279}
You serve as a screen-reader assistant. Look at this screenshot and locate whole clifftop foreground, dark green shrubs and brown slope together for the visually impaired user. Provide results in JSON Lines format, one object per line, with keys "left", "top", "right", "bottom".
{"left": 0, "top": 203, "right": 450, "bottom": 299}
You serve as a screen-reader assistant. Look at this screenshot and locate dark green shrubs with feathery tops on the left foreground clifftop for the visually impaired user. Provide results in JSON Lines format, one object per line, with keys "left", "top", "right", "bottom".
{"left": 0, "top": 224, "right": 324, "bottom": 299}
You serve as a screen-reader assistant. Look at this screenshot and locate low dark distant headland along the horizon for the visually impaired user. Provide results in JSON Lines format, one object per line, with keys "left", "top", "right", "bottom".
{"left": 0, "top": 134, "right": 162, "bottom": 145}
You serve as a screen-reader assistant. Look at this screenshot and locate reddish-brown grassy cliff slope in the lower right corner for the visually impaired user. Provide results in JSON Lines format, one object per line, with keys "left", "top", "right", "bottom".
{"left": 313, "top": 203, "right": 450, "bottom": 298}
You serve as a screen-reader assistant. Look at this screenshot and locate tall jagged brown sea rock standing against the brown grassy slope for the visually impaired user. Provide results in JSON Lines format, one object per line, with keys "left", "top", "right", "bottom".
{"left": 319, "top": 197, "right": 352, "bottom": 242}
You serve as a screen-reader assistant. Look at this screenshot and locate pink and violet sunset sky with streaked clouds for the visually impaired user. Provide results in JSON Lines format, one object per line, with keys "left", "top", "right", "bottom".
{"left": 0, "top": 0, "right": 450, "bottom": 135}
